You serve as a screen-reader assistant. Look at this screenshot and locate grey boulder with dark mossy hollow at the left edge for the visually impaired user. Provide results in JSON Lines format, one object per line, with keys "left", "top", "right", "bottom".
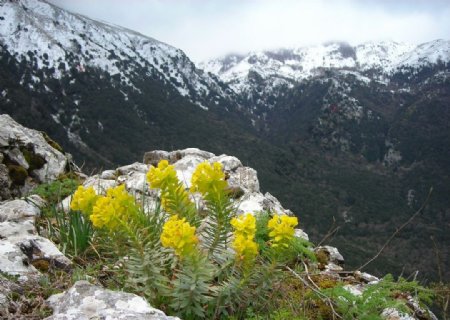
{"left": 0, "top": 114, "right": 73, "bottom": 201}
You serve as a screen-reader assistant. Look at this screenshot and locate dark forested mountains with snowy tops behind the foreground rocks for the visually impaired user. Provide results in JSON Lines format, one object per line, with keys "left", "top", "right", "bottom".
{"left": 0, "top": 0, "right": 450, "bottom": 279}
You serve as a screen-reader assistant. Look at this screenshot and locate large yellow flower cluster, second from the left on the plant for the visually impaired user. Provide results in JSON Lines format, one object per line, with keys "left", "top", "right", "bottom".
{"left": 90, "top": 185, "right": 136, "bottom": 230}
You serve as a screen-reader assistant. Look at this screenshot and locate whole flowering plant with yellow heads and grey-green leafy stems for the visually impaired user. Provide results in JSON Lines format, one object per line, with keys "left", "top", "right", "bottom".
{"left": 69, "top": 161, "right": 310, "bottom": 319}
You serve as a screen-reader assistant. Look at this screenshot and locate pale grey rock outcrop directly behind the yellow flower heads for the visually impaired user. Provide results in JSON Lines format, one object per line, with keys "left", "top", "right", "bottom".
{"left": 77, "top": 148, "right": 308, "bottom": 232}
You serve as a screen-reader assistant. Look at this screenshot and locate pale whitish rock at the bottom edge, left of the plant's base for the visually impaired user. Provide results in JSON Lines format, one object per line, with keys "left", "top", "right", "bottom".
{"left": 46, "top": 281, "right": 178, "bottom": 320}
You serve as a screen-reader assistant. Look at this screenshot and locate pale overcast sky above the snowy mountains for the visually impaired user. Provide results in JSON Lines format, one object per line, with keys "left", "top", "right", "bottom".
{"left": 49, "top": 0, "right": 450, "bottom": 62}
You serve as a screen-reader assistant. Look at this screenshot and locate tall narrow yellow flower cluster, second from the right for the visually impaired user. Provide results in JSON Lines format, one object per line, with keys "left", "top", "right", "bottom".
{"left": 230, "top": 213, "right": 258, "bottom": 263}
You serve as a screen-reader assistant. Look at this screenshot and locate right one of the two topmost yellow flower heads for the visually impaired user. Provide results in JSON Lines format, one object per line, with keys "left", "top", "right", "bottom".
{"left": 191, "top": 161, "right": 228, "bottom": 195}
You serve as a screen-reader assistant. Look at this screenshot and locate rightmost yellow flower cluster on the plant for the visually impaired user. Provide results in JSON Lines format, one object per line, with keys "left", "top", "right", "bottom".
{"left": 267, "top": 214, "right": 298, "bottom": 247}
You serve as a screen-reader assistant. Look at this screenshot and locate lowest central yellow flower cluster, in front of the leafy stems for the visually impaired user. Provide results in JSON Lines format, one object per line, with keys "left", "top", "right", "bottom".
{"left": 160, "top": 215, "right": 198, "bottom": 257}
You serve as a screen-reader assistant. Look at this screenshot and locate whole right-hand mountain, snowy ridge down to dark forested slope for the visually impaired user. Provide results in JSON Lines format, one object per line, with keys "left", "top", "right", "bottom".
{"left": 202, "top": 40, "right": 450, "bottom": 279}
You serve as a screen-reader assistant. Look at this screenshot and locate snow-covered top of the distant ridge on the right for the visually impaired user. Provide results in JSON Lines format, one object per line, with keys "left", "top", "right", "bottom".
{"left": 200, "top": 40, "right": 450, "bottom": 100}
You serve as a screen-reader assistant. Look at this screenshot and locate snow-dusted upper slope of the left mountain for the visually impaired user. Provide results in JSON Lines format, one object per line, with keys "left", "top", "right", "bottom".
{"left": 0, "top": 0, "right": 232, "bottom": 109}
